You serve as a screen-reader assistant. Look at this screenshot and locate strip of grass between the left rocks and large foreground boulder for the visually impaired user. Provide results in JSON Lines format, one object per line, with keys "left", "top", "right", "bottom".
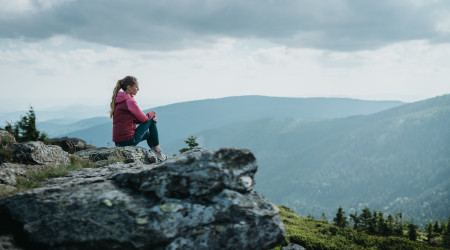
{"left": 0, "top": 156, "right": 94, "bottom": 198}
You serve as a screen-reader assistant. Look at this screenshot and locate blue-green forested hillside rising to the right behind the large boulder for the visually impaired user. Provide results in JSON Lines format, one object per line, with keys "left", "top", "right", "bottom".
{"left": 174, "top": 95, "right": 450, "bottom": 227}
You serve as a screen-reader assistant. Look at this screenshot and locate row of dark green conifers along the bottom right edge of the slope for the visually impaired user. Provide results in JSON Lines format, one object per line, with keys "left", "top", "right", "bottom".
{"left": 333, "top": 207, "right": 450, "bottom": 248}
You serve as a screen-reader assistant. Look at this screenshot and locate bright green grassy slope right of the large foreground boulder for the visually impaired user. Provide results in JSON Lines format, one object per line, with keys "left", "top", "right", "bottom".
{"left": 273, "top": 206, "right": 440, "bottom": 249}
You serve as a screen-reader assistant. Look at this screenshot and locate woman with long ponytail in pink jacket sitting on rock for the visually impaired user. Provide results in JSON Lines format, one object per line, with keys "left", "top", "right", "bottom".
{"left": 109, "top": 76, "right": 167, "bottom": 161}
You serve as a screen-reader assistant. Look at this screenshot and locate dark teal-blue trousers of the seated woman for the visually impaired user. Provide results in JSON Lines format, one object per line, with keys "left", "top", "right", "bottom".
{"left": 116, "top": 119, "right": 159, "bottom": 148}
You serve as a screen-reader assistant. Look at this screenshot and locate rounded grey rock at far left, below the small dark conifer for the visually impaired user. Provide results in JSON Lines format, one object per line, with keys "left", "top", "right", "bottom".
{"left": 7, "top": 141, "right": 70, "bottom": 166}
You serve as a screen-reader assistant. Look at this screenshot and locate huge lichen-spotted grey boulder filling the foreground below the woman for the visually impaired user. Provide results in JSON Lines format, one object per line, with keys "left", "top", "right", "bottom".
{"left": 0, "top": 148, "right": 286, "bottom": 249}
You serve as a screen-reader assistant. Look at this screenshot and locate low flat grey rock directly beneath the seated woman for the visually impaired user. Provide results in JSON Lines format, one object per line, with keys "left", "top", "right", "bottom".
{"left": 75, "top": 146, "right": 158, "bottom": 167}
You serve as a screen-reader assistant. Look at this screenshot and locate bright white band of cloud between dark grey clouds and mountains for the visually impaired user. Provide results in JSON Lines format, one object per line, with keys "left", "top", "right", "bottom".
{"left": 0, "top": 38, "right": 450, "bottom": 113}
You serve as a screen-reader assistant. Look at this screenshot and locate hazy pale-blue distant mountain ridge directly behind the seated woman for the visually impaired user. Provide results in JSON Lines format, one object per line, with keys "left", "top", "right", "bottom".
{"left": 60, "top": 96, "right": 404, "bottom": 146}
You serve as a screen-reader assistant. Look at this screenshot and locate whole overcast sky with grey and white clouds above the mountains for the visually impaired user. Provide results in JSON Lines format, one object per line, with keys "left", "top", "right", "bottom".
{"left": 0, "top": 0, "right": 450, "bottom": 112}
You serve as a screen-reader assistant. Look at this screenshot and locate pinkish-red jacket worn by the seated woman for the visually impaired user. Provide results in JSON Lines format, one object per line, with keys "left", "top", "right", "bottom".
{"left": 113, "top": 91, "right": 155, "bottom": 142}
